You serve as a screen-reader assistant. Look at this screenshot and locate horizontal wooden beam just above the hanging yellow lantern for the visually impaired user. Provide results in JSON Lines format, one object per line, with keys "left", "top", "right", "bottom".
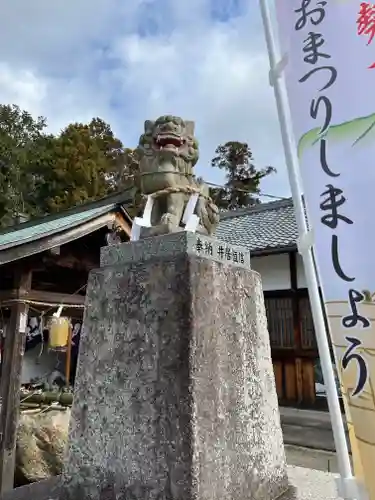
{"left": 0, "top": 289, "right": 85, "bottom": 306}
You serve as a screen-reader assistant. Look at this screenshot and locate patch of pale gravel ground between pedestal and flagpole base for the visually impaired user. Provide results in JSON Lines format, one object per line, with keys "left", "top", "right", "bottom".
{"left": 286, "top": 465, "right": 341, "bottom": 500}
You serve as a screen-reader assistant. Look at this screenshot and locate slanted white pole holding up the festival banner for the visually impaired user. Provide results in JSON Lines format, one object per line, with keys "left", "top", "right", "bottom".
{"left": 259, "top": 0, "right": 360, "bottom": 499}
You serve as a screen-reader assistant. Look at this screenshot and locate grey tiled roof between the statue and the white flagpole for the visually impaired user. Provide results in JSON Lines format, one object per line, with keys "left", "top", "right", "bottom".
{"left": 216, "top": 198, "right": 298, "bottom": 252}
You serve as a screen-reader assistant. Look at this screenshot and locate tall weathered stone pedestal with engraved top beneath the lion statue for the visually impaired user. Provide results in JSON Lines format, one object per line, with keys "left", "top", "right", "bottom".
{"left": 65, "top": 233, "right": 288, "bottom": 500}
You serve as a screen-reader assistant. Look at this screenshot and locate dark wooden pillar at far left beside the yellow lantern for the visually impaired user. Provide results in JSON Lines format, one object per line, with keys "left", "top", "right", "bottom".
{"left": 0, "top": 265, "right": 31, "bottom": 496}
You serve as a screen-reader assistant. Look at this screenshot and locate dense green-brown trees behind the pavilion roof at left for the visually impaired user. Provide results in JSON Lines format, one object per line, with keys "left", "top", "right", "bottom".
{"left": 0, "top": 105, "right": 138, "bottom": 226}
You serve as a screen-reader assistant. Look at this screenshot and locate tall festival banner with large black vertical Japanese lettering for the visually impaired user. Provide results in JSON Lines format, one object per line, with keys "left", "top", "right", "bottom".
{"left": 276, "top": 0, "right": 375, "bottom": 499}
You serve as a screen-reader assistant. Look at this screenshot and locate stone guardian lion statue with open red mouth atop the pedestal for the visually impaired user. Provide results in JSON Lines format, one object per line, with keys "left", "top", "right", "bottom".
{"left": 137, "top": 116, "right": 219, "bottom": 236}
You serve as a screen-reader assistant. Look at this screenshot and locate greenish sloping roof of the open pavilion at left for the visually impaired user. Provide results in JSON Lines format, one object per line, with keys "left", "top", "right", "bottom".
{"left": 0, "top": 188, "right": 134, "bottom": 251}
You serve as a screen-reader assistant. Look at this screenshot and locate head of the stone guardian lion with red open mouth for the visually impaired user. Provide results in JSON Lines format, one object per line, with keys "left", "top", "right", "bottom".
{"left": 138, "top": 115, "right": 199, "bottom": 170}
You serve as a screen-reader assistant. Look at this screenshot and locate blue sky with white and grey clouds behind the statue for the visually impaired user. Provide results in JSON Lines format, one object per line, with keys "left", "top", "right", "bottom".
{"left": 0, "top": 0, "right": 289, "bottom": 201}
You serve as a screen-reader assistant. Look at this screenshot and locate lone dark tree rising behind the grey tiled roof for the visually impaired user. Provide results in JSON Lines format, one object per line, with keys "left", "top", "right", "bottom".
{"left": 211, "top": 141, "right": 276, "bottom": 210}
